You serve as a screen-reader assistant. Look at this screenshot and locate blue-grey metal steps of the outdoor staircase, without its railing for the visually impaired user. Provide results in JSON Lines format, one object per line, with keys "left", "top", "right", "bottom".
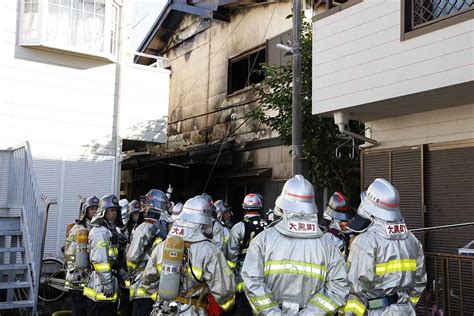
{"left": 0, "top": 214, "right": 34, "bottom": 315}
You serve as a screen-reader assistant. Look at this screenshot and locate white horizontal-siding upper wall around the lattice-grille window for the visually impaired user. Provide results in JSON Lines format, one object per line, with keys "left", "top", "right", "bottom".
{"left": 313, "top": 0, "right": 474, "bottom": 114}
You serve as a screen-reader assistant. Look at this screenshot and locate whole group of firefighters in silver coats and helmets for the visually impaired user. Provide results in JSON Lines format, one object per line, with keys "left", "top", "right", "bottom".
{"left": 64, "top": 175, "right": 426, "bottom": 316}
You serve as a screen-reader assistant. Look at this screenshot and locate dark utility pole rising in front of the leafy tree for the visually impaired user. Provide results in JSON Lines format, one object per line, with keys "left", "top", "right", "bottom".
{"left": 291, "top": 0, "right": 303, "bottom": 176}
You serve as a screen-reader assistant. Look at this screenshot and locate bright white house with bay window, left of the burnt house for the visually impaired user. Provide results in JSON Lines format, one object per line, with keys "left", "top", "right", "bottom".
{"left": 0, "top": 0, "right": 169, "bottom": 256}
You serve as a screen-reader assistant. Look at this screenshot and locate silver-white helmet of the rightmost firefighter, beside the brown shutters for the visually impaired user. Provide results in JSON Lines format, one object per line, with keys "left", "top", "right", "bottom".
{"left": 359, "top": 178, "right": 403, "bottom": 222}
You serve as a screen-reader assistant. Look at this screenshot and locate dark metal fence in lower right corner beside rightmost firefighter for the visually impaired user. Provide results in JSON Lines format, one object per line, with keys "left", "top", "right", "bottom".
{"left": 417, "top": 252, "right": 474, "bottom": 316}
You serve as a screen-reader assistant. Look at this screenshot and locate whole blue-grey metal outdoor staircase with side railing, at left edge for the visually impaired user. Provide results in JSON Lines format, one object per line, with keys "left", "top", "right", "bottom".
{"left": 0, "top": 142, "right": 45, "bottom": 315}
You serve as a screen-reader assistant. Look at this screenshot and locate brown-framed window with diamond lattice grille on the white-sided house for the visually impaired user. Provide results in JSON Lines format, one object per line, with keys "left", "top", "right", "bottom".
{"left": 401, "top": 0, "right": 474, "bottom": 39}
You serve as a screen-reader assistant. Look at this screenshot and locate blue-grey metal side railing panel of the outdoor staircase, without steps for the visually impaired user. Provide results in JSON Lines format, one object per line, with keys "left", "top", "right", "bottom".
{"left": 4, "top": 142, "right": 45, "bottom": 311}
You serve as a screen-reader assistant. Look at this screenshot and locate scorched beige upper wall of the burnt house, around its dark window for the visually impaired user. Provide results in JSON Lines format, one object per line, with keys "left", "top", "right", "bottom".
{"left": 164, "top": 1, "right": 291, "bottom": 178}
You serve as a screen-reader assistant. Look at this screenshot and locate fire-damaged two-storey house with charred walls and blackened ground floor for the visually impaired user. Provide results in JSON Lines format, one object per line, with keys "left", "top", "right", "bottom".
{"left": 131, "top": 1, "right": 320, "bottom": 211}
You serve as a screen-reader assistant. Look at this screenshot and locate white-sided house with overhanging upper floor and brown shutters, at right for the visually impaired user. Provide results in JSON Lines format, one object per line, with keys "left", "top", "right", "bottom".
{"left": 313, "top": 0, "right": 474, "bottom": 314}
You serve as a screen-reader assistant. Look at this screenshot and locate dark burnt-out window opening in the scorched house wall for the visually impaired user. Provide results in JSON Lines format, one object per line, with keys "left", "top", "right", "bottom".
{"left": 227, "top": 47, "right": 266, "bottom": 94}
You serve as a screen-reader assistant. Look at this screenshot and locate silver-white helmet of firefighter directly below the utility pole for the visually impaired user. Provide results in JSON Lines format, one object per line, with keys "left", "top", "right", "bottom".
{"left": 275, "top": 174, "right": 318, "bottom": 214}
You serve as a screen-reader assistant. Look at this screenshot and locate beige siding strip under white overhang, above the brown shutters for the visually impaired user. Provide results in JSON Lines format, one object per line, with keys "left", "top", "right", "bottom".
{"left": 366, "top": 104, "right": 474, "bottom": 149}
